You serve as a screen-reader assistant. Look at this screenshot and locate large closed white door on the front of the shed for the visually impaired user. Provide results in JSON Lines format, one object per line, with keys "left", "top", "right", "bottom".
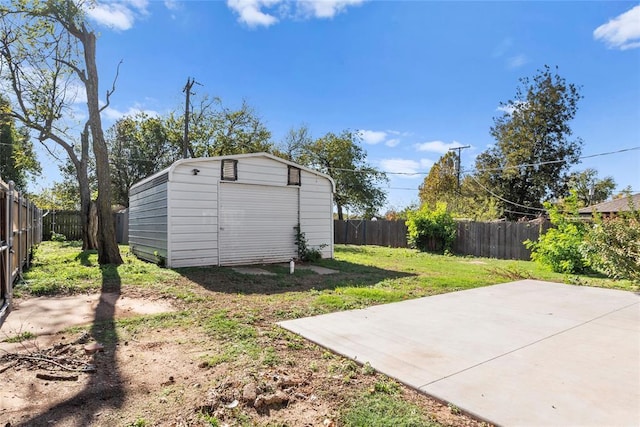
{"left": 218, "top": 182, "right": 299, "bottom": 265}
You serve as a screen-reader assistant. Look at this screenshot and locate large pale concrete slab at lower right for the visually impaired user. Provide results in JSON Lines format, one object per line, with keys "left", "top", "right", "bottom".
{"left": 281, "top": 280, "right": 640, "bottom": 426}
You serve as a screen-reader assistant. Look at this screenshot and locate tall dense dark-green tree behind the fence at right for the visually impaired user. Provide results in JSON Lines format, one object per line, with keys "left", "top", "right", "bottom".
{"left": 475, "top": 66, "right": 582, "bottom": 219}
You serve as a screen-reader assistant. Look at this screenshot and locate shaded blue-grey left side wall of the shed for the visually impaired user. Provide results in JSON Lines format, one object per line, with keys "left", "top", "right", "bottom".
{"left": 129, "top": 179, "right": 168, "bottom": 262}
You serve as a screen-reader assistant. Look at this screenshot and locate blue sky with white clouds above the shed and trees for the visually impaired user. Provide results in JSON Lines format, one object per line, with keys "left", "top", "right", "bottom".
{"left": 36, "top": 0, "right": 640, "bottom": 208}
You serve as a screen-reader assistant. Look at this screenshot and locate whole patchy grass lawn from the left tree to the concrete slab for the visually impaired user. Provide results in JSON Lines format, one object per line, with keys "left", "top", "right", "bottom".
{"left": 15, "top": 242, "right": 638, "bottom": 426}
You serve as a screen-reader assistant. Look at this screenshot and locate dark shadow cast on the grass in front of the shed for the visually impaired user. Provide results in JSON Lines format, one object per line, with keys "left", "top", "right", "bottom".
{"left": 175, "top": 260, "right": 414, "bottom": 295}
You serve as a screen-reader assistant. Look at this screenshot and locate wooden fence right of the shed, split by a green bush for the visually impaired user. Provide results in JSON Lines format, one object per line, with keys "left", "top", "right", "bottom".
{"left": 333, "top": 219, "right": 550, "bottom": 260}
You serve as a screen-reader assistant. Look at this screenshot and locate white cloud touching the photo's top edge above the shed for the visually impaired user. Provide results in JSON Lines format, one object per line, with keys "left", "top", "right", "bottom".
{"left": 227, "top": 0, "right": 366, "bottom": 27}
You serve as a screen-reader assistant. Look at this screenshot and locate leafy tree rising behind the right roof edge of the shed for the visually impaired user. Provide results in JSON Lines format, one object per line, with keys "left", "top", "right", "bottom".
{"left": 296, "top": 130, "right": 387, "bottom": 220}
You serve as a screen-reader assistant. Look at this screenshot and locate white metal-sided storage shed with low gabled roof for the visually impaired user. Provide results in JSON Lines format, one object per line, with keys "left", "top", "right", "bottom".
{"left": 129, "top": 153, "right": 334, "bottom": 267}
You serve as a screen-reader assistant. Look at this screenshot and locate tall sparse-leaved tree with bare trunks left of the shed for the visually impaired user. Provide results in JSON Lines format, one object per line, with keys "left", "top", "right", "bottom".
{"left": 0, "top": 0, "right": 122, "bottom": 264}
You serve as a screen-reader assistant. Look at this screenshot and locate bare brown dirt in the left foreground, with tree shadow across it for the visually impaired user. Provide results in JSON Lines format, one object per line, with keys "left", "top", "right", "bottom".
{"left": 0, "top": 289, "right": 484, "bottom": 426}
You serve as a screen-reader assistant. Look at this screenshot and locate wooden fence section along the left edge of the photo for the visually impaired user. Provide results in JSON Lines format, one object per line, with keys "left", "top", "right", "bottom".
{"left": 0, "top": 180, "right": 42, "bottom": 324}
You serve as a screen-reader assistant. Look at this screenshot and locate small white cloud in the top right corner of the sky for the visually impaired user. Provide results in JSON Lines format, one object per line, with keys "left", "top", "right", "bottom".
{"left": 593, "top": 5, "right": 640, "bottom": 50}
